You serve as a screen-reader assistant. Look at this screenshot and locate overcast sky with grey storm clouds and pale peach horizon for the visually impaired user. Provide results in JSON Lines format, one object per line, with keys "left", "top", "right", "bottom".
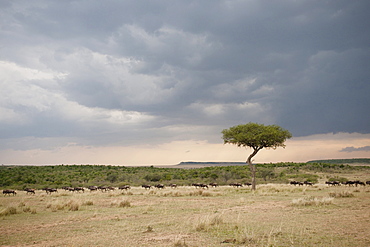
{"left": 0, "top": 0, "right": 370, "bottom": 164}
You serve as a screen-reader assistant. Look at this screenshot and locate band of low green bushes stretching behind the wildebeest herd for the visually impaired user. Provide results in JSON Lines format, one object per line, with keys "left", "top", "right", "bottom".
{"left": 0, "top": 162, "right": 370, "bottom": 189}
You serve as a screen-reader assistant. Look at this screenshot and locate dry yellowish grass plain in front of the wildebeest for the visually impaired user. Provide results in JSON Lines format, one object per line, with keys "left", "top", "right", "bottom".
{"left": 0, "top": 178, "right": 370, "bottom": 247}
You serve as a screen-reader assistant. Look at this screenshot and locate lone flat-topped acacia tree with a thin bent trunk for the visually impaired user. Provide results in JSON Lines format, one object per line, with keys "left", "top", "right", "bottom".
{"left": 221, "top": 123, "right": 292, "bottom": 190}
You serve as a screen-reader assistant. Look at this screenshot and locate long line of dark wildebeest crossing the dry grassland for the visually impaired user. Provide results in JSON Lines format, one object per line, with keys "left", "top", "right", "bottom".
{"left": 3, "top": 180, "right": 370, "bottom": 196}
